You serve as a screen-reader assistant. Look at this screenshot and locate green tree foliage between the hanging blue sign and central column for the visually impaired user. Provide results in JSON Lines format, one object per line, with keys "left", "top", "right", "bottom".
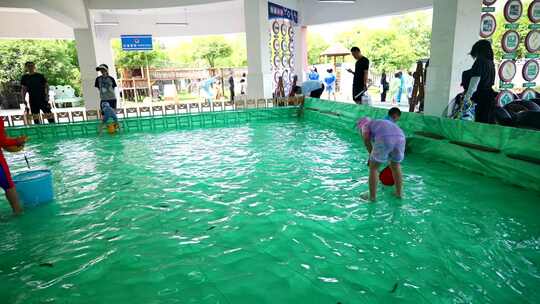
{"left": 193, "top": 36, "right": 233, "bottom": 68}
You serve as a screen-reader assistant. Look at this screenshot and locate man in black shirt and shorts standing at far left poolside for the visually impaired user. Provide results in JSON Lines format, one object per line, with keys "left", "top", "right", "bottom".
{"left": 21, "top": 61, "right": 54, "bottom": 124}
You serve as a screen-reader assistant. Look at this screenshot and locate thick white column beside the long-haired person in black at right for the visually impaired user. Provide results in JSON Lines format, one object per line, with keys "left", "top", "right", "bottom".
{"left": 424, "top": 0, "right": 482, "bottom": 116}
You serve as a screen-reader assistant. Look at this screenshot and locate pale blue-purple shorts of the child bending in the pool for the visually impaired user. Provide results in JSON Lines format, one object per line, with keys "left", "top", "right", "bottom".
{"left": 369, "top": 136, "right": 405, "bottom": 164}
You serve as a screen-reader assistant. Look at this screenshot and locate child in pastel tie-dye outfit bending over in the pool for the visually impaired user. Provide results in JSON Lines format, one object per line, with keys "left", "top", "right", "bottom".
{"left": 357, "top": 108, "right": 405, "bottom": 202}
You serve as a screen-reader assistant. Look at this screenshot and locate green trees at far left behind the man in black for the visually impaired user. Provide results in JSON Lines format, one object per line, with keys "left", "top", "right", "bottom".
{"left": 0, "top": 40, "right": 81, "bottom": 94}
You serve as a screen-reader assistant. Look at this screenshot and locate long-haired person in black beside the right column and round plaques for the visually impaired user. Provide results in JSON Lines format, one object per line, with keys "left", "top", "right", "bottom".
{"left": 461, "top": 40, "right": 497, "bottom": 123}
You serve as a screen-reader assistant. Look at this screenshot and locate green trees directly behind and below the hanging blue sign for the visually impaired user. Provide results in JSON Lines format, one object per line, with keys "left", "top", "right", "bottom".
{"left": 112, "top": 39, "right": 170, "bottom": 68}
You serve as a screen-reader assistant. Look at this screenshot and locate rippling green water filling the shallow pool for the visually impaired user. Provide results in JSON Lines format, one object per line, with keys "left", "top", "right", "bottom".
{"left": 0, "top": 120, "right": 540, "bottom": 304}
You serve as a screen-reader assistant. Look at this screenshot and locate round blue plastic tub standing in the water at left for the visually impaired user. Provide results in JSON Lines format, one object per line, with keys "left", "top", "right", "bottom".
{"left": 13, "top": 170, "right": 54, "bottom": 207}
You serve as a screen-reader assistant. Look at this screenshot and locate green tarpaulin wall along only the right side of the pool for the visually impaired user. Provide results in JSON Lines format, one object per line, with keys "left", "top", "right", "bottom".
{"left": 303, "top": 98, "right": 540, "bottom": 191}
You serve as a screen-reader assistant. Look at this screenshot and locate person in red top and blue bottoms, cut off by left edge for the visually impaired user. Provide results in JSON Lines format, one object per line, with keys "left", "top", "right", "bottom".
{"left": 0, "top": 119, "right": 26, "bottom": 215}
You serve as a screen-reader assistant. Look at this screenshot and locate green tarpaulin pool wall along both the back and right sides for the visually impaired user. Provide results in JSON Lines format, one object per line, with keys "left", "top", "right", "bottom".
{"left": 6, "top": 98, "right": 540, "bottom": 191}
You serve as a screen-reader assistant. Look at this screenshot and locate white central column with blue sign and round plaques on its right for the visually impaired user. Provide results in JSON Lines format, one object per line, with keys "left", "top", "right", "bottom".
{"left": 244, "top": 0, "right": 272, "bottom": 98}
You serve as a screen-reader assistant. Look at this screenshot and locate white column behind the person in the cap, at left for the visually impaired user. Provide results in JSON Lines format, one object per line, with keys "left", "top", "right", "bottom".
{"left": 73, "top": 29, "right": 99, "bottom": 110}
